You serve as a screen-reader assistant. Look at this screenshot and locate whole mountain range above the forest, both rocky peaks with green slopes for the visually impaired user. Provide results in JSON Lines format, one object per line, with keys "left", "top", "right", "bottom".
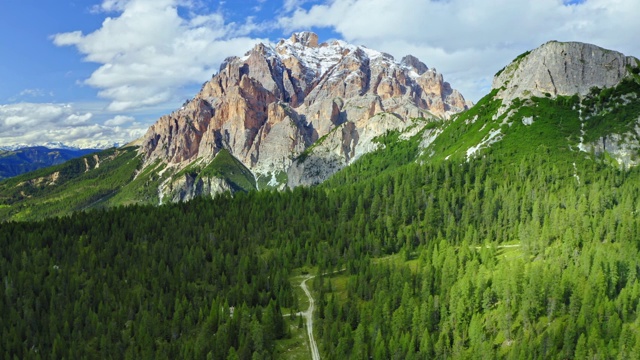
{"left": 0, "top": 39, "right": 640, "bottom": 219}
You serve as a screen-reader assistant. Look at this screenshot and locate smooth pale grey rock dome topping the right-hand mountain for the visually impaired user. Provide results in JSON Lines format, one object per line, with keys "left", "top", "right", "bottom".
{"left": 493, "top": 41, "right": 638, "bottom": 103}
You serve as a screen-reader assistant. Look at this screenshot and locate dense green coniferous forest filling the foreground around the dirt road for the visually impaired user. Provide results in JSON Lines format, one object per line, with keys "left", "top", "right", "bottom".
{"left": 0, "top": 125, "right": 640, "bottom": 359}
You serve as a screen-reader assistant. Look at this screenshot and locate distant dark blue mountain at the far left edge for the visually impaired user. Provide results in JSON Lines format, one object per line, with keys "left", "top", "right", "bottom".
{"left": 0, "top": 146, "right": 100, "bottom": 180}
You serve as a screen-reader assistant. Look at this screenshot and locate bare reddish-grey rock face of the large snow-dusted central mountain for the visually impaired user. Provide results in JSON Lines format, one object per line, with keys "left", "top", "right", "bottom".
{"left": 140, "top": 32, "right": 467, "bottom": 194}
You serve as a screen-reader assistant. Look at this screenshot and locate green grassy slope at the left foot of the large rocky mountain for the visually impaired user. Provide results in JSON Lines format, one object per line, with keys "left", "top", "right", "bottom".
{"left": 0, "top": 148, "right": 256, "bottom": 220}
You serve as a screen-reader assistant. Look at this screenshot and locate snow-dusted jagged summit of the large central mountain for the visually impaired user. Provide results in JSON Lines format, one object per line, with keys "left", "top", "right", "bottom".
{"left": 215, "top": 32, "right": 466, "bottom": 111}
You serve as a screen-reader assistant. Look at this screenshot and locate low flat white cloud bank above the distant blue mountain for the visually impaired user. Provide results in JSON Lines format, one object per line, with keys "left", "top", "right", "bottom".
{"left": 0, "top": 103, "right": 146, "bottom": 148}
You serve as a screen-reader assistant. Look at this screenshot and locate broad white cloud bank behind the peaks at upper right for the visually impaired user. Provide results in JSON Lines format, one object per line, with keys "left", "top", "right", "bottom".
{"left": 279, "top": 0, "right": 640, "bottom": 100}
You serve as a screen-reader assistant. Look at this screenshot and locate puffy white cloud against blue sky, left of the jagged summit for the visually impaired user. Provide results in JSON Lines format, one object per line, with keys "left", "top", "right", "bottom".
{"left": 53, "top": 0, "right": 260, "bottom": 112}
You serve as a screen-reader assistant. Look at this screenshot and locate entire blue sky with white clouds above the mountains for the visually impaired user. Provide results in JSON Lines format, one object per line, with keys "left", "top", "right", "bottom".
{"left": 0, "top": 0, "right": 640, "bottom": 148}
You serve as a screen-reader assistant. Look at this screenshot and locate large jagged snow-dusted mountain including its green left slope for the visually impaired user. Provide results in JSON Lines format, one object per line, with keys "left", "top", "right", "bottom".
{"left": 0, "top": 32, "right": 469, "bottom": 219}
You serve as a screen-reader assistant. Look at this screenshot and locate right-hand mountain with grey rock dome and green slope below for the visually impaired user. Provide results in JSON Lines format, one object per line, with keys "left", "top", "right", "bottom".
{"left": 425, "top": 41, "right": 640, "bottom": 167}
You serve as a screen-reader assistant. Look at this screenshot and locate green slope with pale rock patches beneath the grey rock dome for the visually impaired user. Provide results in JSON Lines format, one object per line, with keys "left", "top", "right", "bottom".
{"left": 424, "top": 75, "right": 640, "bottom": 170}
